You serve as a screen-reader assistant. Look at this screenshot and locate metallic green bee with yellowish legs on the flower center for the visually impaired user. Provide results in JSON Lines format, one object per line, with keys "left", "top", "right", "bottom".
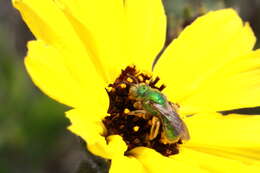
{"left": 129, "top": 84, "right": 190, "bottom": 144}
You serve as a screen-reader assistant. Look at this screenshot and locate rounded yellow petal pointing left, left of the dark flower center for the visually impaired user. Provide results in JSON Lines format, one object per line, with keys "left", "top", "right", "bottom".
{"left": 25, "top": 41, "right": 108, "bottom": 108}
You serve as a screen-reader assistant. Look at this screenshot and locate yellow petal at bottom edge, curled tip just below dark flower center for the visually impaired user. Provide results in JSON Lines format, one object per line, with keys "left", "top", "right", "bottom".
{"left": 131, "top": 147, "right": 208, "bottom": 173}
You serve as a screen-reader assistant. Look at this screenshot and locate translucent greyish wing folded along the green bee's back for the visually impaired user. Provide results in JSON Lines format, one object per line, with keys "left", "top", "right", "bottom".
{"left": 152, "top": 103, "right": 190, "bottom": 140}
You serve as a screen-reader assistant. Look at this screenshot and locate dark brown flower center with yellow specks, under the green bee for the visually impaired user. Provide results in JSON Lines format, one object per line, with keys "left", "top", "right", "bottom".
{"left": 103, "top": 66, "right": 182, "bottom": 156}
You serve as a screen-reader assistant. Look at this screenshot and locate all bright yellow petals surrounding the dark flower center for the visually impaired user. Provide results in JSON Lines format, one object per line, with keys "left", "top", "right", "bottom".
{"left": 13, "top": 0, "right": 260, "bottom": 173}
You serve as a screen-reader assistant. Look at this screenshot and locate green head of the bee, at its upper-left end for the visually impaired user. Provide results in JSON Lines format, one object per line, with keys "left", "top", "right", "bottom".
{"left": 129, "top": 83, "right": 150, "bottom": 99}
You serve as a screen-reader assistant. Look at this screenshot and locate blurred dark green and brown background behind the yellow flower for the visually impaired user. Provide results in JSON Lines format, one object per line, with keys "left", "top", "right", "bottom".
{"left": 0, "top": 0, "right": 260, "bottom": 173}
